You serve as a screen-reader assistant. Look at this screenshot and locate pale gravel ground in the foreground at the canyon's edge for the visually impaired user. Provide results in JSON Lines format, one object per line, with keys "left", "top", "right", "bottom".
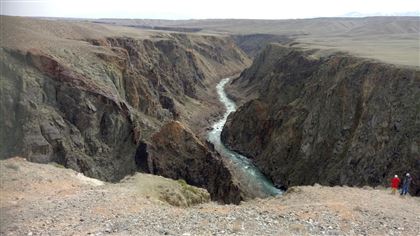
{"left": 0, "top": 159, "right": 420, "bottom": 235}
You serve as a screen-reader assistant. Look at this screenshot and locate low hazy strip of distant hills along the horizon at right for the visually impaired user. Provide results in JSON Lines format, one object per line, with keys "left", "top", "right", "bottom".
{"left": 95, "top": 16, "right": 420, "bottom": 36}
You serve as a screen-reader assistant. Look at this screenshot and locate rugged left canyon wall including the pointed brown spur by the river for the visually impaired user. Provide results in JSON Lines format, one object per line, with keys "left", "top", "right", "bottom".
{"left": 0, "top": 22, "right": 250, "bottom": 203}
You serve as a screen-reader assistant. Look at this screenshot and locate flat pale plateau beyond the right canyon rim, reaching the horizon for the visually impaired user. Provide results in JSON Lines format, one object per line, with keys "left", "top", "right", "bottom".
{"left": 95, "top": 16, "right": 420, "bottom": 67}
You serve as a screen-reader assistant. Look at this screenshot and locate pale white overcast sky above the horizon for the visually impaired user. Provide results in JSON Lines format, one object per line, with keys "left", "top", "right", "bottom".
{"left": 0, "top": 0, "right": 420, "bottom": 19}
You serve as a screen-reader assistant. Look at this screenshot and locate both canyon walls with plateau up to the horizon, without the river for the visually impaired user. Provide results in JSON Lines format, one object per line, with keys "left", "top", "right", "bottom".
{"left": 0, "top": 16, "right": 420, "bottom": 204}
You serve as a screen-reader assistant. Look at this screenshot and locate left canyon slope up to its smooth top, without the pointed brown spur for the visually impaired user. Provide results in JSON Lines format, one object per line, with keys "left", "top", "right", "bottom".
{"left": 0, "top": 16, "right": 249, "bottom": 201}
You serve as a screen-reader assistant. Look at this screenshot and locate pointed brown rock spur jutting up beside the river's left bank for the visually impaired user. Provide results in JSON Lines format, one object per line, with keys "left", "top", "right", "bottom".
{"left": 136, "top": 121, "right": 243, "bottom": 203}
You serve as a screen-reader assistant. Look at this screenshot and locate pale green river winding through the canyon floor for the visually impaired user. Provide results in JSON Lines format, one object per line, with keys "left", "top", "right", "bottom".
{"left": 208, "top": 78, "right": 282, "bottom": 198}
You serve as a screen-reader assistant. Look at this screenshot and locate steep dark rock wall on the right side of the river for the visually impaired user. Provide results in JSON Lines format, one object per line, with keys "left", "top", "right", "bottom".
{"left": 222, "top": 44, "right": 420, "bottom": 196}
